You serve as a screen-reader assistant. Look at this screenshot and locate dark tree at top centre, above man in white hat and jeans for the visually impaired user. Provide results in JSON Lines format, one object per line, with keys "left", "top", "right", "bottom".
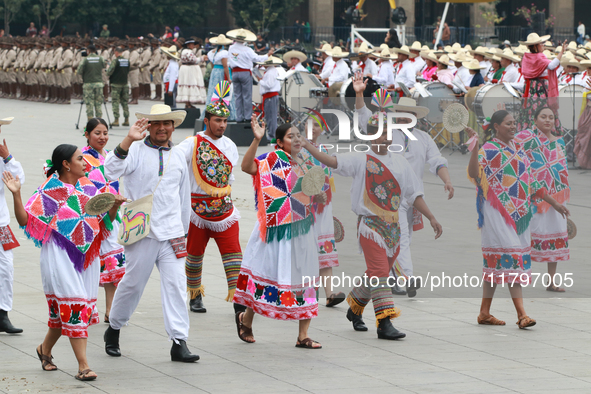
{"left": 231, "top": 0, "right": 302, "bottom": 33}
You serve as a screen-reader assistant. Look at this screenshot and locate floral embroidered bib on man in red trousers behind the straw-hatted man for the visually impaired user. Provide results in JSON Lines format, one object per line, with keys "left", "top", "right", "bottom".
{"left": 193, "top": 134, "right": 233, "bottom": 197}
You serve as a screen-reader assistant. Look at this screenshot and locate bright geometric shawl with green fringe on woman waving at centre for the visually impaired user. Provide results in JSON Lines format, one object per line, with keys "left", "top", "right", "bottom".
{"left": 253, "top": 150, "right": 314, "bottom": 243}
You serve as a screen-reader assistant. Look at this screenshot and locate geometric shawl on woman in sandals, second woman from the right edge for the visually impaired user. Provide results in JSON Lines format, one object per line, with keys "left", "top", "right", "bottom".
{"left": 470, "top": 138, "right": 545, "bottom": 234}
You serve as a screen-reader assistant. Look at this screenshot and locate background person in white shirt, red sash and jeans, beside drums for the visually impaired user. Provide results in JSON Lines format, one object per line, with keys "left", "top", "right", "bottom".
{"left": 258, "top": 56, "right": 282, "bottom": 142}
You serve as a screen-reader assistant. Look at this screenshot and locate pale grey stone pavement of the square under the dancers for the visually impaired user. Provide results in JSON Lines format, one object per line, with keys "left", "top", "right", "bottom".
{"left": 0, "top": 99, "right": 591, "bottom": 394}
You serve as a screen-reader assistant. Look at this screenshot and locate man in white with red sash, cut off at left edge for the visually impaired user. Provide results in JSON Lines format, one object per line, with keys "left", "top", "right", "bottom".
{"left": 0, "top": 119, "right": 25, "bottom": 334}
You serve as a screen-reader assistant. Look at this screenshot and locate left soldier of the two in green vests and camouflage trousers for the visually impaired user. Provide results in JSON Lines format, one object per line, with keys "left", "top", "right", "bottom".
{"left": 76, "top": 53, "right": 105, "bottom": 120}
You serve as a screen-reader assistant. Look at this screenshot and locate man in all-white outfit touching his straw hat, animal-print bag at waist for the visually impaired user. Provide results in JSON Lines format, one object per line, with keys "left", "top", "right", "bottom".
{"left": 104, "top": 104, "right": 199, "bottom": 362}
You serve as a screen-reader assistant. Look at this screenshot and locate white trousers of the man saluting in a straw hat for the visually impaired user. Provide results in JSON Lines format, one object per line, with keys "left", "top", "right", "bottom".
{"left": 109, "top": 237, "right": 189, "bottom": 341}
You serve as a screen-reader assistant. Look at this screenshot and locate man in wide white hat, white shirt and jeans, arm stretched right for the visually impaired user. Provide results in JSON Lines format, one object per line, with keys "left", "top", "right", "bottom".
{"left": 226, "top": 29, "right": 273, "bottom": 122}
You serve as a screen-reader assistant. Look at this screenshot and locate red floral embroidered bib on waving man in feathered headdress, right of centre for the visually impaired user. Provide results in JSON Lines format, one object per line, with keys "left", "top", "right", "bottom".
{"left": 363, "top": 155, "right": 402, "bottom": 223}
